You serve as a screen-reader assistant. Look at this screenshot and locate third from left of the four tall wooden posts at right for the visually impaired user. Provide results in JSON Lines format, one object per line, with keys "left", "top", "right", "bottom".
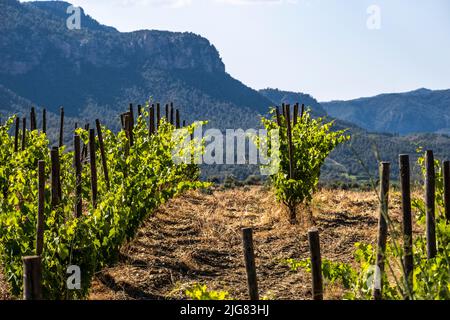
{"left": 425, "top": 150, "right": 437, "bottom": 259}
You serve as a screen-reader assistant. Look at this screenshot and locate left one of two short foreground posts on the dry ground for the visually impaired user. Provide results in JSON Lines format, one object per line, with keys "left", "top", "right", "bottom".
{"left": 242, "top": 228, "right": 259, "bottom": 300}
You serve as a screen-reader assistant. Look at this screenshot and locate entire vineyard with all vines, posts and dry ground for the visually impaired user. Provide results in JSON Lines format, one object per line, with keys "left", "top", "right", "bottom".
{"left": 0, "top": 104, "right": 450, "bottom": 300}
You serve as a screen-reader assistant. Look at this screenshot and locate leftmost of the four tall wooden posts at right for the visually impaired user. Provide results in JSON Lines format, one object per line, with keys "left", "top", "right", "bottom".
{"left": 373, "top": 162, "right": 390, "bottom": 300}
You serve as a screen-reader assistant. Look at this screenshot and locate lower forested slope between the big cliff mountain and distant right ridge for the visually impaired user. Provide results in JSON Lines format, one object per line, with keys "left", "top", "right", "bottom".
{"left": 260, "top": 89, "right": 450, "bottom": 185}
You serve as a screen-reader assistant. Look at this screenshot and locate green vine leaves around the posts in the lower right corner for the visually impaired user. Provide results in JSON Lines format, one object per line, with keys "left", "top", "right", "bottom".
{"left": 286, "top": 150, "right": 450, "bottom": 300}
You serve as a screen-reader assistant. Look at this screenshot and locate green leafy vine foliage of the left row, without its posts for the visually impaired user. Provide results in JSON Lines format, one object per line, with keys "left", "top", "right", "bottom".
{"left": 0, "top": 107, "right": 207, "bottom": 299}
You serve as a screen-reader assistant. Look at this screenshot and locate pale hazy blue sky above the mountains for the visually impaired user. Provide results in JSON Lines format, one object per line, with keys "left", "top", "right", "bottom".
{"left": 20, "top": 0, "right": 450, "bottom": 101}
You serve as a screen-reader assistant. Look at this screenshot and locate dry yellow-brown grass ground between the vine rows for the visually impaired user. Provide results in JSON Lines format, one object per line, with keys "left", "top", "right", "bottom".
{"left": 90, "top": 186, "right": 400, "bottom": 299}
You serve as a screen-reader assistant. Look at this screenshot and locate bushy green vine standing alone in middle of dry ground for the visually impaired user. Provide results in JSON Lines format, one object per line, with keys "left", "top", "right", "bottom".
{"left": 255, "top": 109, "right": 350, "bottom": 220}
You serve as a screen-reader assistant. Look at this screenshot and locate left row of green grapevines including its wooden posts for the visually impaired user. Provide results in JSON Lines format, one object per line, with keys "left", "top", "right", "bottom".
{"left": 0, "top": 105, "right": 204, "bottom": 299}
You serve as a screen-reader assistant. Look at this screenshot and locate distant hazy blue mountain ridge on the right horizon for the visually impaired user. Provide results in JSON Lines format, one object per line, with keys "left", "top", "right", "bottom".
{"left": 321, "top": 89, "right": 450, "bottom": 135}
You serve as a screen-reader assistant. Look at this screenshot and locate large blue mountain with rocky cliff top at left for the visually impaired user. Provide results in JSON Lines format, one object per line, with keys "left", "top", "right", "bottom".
{"left": 0, "top": 0, "right": 271, "bottom": 128}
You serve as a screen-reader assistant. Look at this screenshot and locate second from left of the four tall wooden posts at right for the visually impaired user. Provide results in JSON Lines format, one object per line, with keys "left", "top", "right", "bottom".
{"left": 399, "top": 154, "right": 413, "bottom": 291}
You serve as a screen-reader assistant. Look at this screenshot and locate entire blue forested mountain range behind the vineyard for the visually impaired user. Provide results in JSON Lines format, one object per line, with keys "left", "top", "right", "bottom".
{"left": 0, "top": 0, "right": 450, "bottom": 183}
